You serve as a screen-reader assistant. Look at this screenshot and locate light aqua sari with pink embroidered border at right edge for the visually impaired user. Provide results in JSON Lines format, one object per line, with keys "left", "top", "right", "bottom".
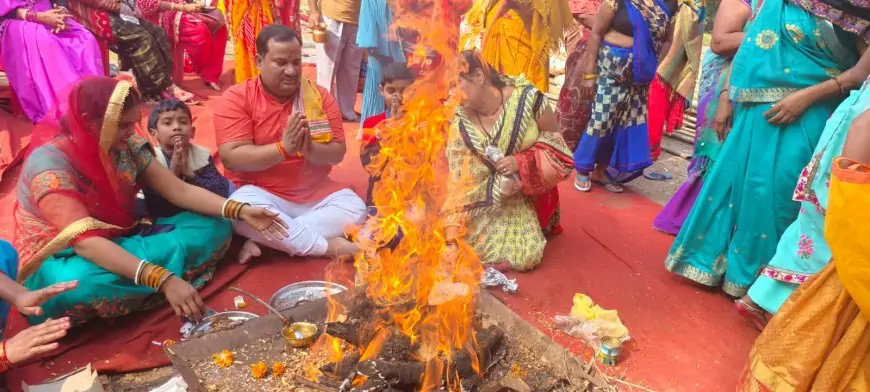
{"left": 749, "top": 83, "right": 870, "bottom": 313}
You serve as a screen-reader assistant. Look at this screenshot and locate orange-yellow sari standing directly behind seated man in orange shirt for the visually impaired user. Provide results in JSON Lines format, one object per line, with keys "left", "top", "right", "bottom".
{"left": 218, "top": 0, "right": 275, "bottom": 83}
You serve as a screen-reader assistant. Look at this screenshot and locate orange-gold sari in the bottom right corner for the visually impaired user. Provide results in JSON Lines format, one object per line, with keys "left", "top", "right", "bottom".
{"left": 738, "top": 157, "right": 870, "bottom": 392}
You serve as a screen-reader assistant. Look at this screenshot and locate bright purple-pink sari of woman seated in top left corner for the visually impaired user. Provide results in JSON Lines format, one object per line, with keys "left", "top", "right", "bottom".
{"left": 0, "top": 0, "right": 103, "bottom": 123}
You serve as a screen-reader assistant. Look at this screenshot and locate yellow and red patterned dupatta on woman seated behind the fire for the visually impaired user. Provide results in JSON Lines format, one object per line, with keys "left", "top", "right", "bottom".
{"left": 442, "top": 77, "right": 574, "bottom": 226}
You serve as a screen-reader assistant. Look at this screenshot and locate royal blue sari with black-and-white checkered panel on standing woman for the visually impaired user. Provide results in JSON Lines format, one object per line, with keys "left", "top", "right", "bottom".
{"left": 574, "top": 0, "right": 676, "bottom": 183}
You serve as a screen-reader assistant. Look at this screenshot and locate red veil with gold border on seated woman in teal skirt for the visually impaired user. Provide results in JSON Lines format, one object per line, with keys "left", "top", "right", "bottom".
{"left": 14, "top": 78, "right": 148, "bottom": 281}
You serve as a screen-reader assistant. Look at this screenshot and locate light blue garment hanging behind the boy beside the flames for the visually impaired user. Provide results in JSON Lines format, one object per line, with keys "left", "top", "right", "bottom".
{"left": 356, "top": 0, "right": 405, "bottom": 124}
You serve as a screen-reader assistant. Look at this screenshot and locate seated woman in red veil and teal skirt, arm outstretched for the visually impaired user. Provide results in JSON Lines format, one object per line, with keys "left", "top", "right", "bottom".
{"left": 15, "top": 77, "right": 286, "bottom": 325}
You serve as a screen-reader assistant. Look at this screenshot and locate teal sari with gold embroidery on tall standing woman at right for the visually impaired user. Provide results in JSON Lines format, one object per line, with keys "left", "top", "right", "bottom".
{"left": 665, "top": 0, "right": 857, "bottom": 297}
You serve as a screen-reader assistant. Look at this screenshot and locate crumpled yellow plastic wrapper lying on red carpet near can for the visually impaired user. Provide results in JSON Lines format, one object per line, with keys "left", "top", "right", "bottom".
{"left": 555, "top": 293, "right": 631, "bottom": 345}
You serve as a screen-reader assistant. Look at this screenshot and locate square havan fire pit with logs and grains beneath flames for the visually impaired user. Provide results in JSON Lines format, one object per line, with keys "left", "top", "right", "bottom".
{"left": 165, "top": 290, "right": 606, "bottom": 392}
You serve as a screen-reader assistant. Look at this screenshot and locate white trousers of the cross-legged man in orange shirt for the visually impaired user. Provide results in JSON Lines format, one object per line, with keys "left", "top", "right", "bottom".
{"left": 230, "top": 185, "right": 366, "bottom": 256}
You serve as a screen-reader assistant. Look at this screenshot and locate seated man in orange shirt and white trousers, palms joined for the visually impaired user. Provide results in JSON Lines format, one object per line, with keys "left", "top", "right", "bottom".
{"left": 214, "top": 25, "right": 366, "bottom": 262}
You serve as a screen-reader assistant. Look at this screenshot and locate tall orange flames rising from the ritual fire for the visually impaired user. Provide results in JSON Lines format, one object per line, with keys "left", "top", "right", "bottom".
{"left": 312, "top": 0, "right": 482, "bottom": 391}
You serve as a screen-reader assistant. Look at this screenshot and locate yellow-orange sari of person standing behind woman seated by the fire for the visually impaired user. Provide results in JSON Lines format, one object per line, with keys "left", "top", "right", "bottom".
{"left": 460, "top": 0, "right": 574, "bottom": 93}
